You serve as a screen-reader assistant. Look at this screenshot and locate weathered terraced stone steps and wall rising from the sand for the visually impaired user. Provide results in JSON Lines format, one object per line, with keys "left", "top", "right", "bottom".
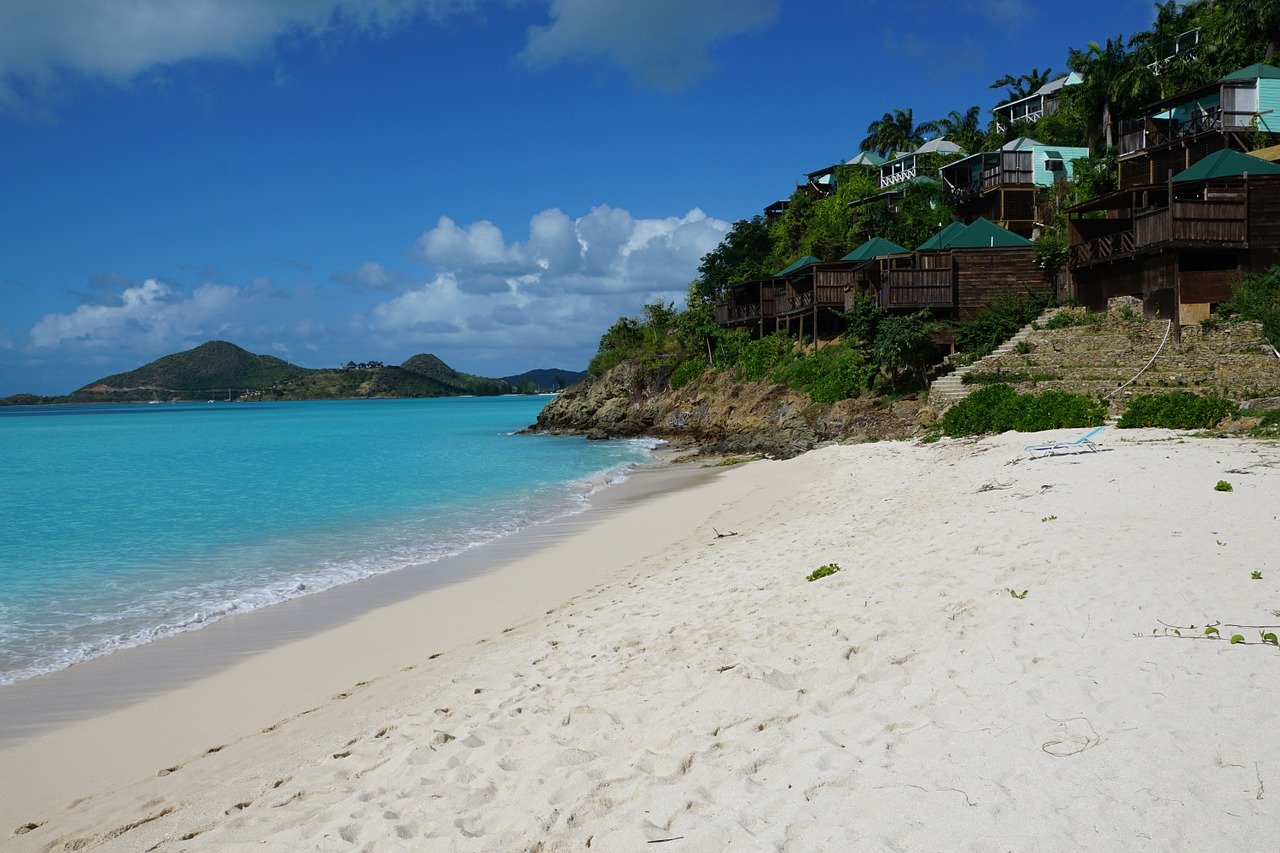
{"left": 931, "top": 298, "right": 1280, "bottom": 414}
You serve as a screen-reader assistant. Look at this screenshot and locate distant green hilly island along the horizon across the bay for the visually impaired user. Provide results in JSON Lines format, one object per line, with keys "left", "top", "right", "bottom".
{"left": 0, "top": 341, "right": 586, "bottom": 406}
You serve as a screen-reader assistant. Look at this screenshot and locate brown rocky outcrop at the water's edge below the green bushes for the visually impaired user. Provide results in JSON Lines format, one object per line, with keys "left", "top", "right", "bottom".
{"left": 530, "top": 362, "right": 919, "bottom": 459}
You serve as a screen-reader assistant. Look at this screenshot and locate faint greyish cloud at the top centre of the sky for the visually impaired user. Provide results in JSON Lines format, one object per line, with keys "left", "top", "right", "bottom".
{"left": 521, "top": 0, "right": 778, "bottom": 91}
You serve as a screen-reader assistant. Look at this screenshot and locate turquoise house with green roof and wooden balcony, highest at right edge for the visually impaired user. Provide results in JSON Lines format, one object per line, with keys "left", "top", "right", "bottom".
{"left": 1119, "top": 64, "right": 1280, "bottom": 190}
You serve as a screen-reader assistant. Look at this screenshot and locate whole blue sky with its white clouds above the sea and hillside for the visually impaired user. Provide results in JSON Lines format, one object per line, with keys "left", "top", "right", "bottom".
{"left": 0, "top": 0, "right": 1153, "bottom": 396}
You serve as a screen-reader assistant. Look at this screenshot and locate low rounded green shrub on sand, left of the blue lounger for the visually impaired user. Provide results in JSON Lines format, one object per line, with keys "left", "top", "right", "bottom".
{"left": 942, "top": 384, "right": 1106, "bottom": 437}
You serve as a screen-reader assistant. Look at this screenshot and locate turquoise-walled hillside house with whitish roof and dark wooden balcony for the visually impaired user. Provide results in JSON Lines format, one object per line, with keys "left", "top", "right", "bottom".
{"left": 938, "top": 137, "right": 1089, "bottom": 237}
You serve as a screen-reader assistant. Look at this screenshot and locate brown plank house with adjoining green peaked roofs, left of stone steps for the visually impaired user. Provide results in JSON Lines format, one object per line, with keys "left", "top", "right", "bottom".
{"left": 881, "top": 218, "right": 1051, "bottom": 320}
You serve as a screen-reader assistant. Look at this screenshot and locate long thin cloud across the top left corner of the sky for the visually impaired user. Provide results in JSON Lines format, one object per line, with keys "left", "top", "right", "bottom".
{"left": 0, "top": 0, "right": 470, "bottom": 111}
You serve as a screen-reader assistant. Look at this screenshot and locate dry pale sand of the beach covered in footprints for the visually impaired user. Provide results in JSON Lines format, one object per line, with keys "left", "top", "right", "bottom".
{"left": 0, "top": 430, "right": 1280, "bottom": 850}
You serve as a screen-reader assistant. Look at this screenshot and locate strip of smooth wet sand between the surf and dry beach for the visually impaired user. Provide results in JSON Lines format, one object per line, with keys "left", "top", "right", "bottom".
{"left": 0, "top": 446, "right": 709, "bottom": 748}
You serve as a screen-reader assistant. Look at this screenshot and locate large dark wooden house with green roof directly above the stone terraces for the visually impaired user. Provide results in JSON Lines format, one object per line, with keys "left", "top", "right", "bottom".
{"left": 1069, "top": 149, "right": 1280, "bottom": 329}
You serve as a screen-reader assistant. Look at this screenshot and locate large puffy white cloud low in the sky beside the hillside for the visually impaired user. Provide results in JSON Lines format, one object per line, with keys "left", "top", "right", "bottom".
{"left": 364, "top": 205, "right": 730, "bottom": 365}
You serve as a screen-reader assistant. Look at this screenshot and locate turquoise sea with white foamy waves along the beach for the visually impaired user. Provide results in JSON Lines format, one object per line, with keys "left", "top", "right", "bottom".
{"left": 0, "top": 397, "right": 653, "bottom": 684}
